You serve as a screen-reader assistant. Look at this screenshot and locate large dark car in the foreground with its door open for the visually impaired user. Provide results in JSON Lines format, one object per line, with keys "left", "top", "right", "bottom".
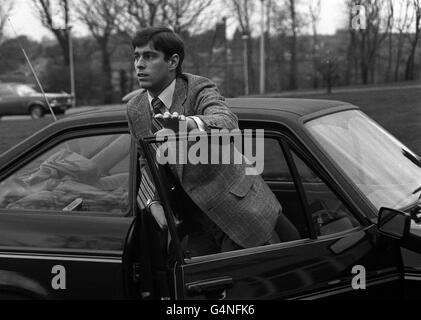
{"left": 0, "top": 99, "right": 421, "bottom": 300}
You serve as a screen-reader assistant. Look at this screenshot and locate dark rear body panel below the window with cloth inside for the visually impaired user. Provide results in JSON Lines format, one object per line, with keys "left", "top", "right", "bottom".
{"left": 0, "top": 212, "right": 133, "bottom": 299}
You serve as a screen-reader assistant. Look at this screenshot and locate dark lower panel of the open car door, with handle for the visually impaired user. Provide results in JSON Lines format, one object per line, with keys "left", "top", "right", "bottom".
{"left": 178, "top": 225, "right": 399, "bottom": 300}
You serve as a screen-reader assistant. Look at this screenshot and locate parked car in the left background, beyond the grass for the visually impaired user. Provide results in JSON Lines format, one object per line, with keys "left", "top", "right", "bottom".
{"left": 0, "top": 83, "right": 73, "bottom": 119}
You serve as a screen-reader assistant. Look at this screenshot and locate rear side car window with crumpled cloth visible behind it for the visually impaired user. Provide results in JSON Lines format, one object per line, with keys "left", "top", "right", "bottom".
{"left": 0, "top": 134, "right": 130, "bottom": 216}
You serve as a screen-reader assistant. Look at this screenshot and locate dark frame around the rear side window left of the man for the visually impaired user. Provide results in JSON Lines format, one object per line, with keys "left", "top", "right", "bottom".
{"left": 0, "top": 125, "right": 137, "bottom": 218}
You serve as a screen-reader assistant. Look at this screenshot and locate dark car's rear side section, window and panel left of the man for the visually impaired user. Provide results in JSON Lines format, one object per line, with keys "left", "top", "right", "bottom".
{"left": 0, "top": 125, "right": 136, "bottom": 299}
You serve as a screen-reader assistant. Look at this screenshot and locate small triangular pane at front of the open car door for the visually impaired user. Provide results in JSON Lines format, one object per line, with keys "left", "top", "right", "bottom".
{"left": 291, "top": 151, "right": 360, "bottom": 236}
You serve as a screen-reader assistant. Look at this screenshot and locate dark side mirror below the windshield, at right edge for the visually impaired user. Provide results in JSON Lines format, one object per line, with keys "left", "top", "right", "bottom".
{"left": 377, "top": 208, "right": 411, "bottom": 240}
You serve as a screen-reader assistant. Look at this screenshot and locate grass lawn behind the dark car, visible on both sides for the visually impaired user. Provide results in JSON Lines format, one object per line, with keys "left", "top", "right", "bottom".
{"left": 0, "top": 86, "right": 421, "bottom": 154}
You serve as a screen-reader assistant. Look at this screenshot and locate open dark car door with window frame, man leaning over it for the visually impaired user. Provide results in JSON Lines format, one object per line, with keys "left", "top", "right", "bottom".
{"left": 142, "top": 130, "right": 401, "bottom": 300}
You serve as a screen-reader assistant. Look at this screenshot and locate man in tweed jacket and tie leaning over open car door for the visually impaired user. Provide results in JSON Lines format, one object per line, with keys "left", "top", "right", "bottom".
{"left": 127, "top": 28, "right": 299, "bottom": 255}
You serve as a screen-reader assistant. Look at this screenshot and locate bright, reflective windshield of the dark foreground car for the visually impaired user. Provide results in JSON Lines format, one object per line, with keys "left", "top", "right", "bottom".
{"left": 306, "top": 110, "right": 421, "bottom": 210}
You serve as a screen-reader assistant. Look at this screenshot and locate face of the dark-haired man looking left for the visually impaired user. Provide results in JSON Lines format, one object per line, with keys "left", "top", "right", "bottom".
{"left": 134, "top": 44, "right": 178, "bottom": 95}
